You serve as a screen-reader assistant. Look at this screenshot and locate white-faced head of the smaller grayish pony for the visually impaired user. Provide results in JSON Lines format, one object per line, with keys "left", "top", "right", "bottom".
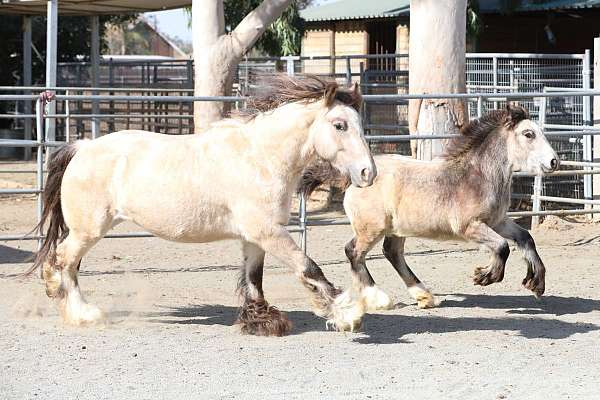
{"left": 505, "top": 105, "right": 559, "bottom": 174}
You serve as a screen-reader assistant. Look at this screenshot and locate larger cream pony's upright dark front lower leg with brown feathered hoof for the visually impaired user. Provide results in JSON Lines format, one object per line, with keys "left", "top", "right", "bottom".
{"left": 236, "top": 242, "right": 292, "bottom": 336}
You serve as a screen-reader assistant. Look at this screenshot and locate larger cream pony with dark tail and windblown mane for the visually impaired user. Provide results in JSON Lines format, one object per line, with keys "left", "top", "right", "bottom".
{"left": 30, "top": 76, "right": 376, "bottom": 335}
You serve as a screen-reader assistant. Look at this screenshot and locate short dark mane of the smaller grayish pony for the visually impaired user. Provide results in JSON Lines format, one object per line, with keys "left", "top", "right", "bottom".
{"left": 444, "top": 105, "right": 529, "bottom": 160}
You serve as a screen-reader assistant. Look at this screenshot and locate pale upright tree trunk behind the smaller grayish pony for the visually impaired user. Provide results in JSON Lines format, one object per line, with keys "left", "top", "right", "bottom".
{"left": 408, "top": 0, "right": 468, "bottom": 160}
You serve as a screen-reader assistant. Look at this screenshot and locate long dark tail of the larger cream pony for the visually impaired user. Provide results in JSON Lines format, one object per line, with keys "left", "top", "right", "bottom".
{"left": 25, "top": 142, "right": 78, "bottom": 275}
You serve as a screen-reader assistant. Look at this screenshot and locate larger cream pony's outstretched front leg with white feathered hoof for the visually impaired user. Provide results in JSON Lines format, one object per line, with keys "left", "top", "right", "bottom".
{"left": 251, "top": 225, "right": 365, "bottom": 331}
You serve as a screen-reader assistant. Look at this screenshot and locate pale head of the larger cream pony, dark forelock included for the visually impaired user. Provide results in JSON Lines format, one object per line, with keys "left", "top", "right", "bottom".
{"left": 310, "top": 83, "right": 377, "bottom": 187}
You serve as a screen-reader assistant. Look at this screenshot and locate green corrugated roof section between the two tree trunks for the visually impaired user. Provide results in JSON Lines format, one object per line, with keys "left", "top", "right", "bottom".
{"left": 300, "top": 0, "right": 410, "bottom": 21}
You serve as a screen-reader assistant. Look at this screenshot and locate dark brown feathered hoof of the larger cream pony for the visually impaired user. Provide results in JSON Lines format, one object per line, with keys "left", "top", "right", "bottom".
{"left": 235, "top": 301, "right": 292, "bottom": 336}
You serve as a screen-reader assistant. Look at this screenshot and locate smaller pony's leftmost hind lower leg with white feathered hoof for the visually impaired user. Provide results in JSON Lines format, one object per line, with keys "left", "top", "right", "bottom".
{"left": 344, "top": 235, "right": 394, "bottom": 311}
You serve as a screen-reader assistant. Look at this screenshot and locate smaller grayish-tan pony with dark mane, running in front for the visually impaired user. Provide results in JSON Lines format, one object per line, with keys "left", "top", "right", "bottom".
{"left": 300, "top": 106, "right": 559, "bottom": 330}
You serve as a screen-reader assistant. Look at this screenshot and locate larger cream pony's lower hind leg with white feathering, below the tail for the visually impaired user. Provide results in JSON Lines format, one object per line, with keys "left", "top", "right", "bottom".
{"left": 43, "top": 231, "right": 104, "bottom": 325}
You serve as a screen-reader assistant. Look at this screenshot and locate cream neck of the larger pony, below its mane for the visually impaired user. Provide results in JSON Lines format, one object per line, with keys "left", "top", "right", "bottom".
{"left": 248, "top": 104, "right": 318, "bottom": 181}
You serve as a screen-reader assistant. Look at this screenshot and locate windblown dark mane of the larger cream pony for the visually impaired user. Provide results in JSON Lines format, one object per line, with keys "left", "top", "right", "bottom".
{"left": 232, "top": 74, "right": 362, "bottom": 119}
